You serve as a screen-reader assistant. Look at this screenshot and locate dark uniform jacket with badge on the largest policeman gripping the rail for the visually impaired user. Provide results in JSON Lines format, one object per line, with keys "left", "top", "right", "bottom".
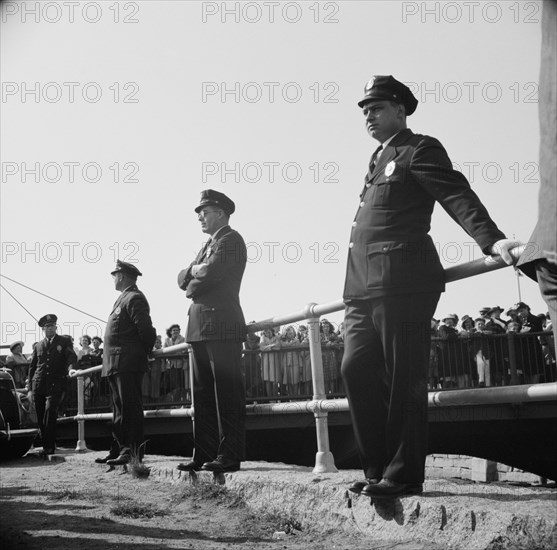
{"left": 344, "top": 129, "right": 505, "bottom": 301}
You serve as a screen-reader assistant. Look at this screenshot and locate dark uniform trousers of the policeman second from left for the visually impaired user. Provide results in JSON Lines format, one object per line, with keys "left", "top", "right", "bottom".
{"left": 108, "top": 372, "right": 144, "bottom": 459}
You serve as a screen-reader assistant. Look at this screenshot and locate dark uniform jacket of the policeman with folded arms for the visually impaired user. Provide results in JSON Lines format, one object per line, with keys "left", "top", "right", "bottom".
{"left": 178, "top": 226, "right": 247, "bottom": 342}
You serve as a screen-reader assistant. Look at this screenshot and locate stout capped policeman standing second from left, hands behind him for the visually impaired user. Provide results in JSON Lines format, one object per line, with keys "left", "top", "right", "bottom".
{"left": 95, "top": 260, "right": 156, "bottom": 466}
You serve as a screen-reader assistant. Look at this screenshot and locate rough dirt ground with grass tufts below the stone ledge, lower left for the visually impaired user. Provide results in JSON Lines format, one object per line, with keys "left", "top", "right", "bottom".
{"left": 0, "top": 455, "right": 432, "bottom": 550}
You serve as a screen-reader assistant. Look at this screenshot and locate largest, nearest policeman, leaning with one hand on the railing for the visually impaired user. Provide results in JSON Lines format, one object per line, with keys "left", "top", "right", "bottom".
{"left": 342, "top": 75, "right": 518, "bottom": 498}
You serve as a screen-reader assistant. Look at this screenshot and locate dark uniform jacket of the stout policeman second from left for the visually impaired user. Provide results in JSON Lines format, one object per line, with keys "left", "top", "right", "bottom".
{"left": 102, "top": 285, "right": 156, "bottom": 376}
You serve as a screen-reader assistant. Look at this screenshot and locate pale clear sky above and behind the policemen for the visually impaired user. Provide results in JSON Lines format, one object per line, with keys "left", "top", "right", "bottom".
{"left": 0, "top": 0, "right": 546, "bottom": 353}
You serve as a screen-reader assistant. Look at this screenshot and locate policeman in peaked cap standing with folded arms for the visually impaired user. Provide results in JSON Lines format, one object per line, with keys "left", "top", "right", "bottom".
{"left": 178, "top": 189, "right": 247, "bottom": 472}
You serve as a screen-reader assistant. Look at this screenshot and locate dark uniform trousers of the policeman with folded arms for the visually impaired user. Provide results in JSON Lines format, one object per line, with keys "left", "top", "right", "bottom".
{"left": 191, "top": 340, "right": 246, "bottom": 463}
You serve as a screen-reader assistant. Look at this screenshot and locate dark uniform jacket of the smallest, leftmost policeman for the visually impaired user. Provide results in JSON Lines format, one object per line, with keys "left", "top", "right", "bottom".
{"left": 29, "top": 334, "right": 77, "bottom": 395}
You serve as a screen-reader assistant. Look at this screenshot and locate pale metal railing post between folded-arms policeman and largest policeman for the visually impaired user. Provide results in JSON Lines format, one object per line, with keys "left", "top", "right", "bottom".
{"left": 308, "top": 312, "right": 338, "bottom": 474}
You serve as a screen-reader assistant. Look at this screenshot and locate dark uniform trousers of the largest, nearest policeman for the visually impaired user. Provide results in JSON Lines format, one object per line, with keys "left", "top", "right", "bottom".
{"left": 341, "top": 293, "right": 440, "bottom": 483}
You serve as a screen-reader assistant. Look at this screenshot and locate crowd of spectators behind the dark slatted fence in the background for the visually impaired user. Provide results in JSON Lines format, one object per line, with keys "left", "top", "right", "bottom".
{"left": 1, "top": 302, "right": 557, "bottom": 405}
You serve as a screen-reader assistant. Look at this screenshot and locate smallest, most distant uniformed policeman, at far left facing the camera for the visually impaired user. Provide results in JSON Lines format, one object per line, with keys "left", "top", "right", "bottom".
{"left": 28, "top": 314, "right": 77, "bottom": 457}
